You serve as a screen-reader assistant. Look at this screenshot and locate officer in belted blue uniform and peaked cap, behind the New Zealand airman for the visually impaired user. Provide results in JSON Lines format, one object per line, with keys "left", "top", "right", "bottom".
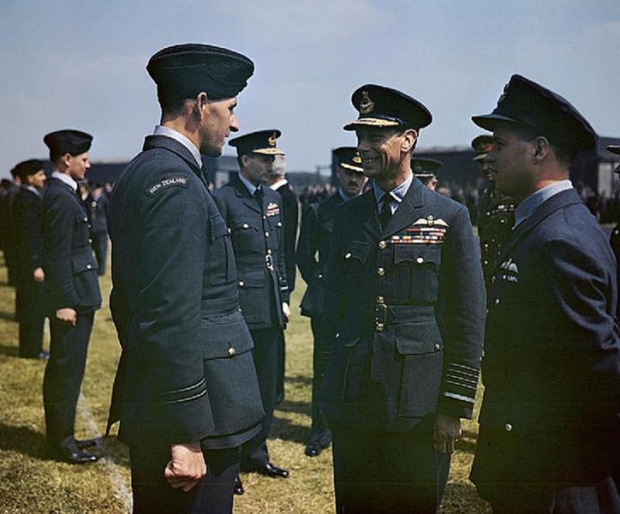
{"left": 214, "top": 130, "right": 290, "bottom": 493}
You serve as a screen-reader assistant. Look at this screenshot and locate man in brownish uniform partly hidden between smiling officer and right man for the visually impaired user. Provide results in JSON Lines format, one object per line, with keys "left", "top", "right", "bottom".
{"left": 471, "top": 134, "right": 515, "bottom": 288}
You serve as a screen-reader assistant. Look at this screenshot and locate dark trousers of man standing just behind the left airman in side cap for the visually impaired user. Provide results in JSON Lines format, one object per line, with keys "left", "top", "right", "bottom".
{"left": 15, "top": 279, "right": 45, "bottom": 358}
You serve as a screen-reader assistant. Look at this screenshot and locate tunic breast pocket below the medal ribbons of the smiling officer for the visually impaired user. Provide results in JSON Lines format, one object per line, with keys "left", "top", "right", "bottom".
{"left": 388, "top": 244, "right": 441, "bottom": 302}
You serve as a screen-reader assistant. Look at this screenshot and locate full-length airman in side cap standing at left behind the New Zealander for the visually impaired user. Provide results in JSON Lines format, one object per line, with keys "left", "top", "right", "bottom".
{"left": 41, "top": 130, "right": 101, "bottom": 464}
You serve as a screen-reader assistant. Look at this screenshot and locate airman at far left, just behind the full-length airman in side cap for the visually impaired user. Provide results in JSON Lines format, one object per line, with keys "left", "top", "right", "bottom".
{"left": 13, "top": 159, "right": 49, "bottom": 359}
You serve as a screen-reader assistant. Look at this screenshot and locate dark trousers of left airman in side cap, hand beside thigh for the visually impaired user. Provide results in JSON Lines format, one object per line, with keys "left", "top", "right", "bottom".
{"left": 43, "top": 312, "right": 95, "bottom": 448}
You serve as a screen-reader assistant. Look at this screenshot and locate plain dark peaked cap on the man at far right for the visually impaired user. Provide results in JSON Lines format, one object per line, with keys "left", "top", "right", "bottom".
{"left": 472, "top": 75, "right": 596, "bottom": 152}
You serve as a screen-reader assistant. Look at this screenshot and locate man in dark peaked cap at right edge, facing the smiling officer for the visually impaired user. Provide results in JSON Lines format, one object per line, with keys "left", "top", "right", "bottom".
{"left": 471, "top": 75, "right": 620, "bottom": 514}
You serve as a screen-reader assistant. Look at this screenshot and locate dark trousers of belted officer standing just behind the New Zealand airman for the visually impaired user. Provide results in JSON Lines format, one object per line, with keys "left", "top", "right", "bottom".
{"left": 241, "top": 326, "right": 282, "bottom": 471}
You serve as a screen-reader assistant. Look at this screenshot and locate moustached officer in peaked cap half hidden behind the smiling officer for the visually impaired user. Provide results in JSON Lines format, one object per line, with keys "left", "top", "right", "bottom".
{"left": 297, "top": 146, "right": 366, "bottom": 457}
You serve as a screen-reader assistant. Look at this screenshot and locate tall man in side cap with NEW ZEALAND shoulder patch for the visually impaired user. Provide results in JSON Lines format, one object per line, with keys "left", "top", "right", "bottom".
{"left": 108, "top": 44, "right": 263, "bottom": 514}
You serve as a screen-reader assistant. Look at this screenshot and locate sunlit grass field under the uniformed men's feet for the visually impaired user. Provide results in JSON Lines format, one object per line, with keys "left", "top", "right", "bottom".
{"left": 0, "top": 253, "right": 490, "bottom": 514}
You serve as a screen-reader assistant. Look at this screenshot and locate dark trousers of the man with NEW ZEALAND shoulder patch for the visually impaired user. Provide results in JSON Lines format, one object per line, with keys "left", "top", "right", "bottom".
{"left": 129, "top": 436, "right": 240, "bottom": 514}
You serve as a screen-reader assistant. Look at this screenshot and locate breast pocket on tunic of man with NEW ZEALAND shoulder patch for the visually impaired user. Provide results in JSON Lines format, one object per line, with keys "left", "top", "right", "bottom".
{"left": 205, "top": 214, "right": 237, "bottom": 285}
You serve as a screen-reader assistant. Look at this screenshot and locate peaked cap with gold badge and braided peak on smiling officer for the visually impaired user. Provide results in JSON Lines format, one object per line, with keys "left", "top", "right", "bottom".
{"left": 344, "top": 84, "right": 433, "bottom": 130}
